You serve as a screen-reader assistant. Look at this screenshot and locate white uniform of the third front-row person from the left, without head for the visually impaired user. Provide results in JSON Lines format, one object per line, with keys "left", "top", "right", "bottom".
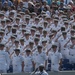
{"left": 24, "top": 55, "right": 33, "bottom": 72}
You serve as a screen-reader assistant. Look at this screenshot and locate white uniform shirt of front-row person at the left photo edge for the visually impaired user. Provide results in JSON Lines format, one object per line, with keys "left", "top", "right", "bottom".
{"left": 0, "top": 50, "right": 10, "bottom": 71}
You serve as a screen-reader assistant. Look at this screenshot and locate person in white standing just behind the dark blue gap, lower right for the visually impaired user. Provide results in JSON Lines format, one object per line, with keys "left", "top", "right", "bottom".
{"left": 59, "top": 31, "right": 69, "bottom": 59}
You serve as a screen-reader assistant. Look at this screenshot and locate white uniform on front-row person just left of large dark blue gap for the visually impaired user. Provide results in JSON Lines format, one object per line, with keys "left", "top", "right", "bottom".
{"left": 48, "top": 51, "right": 62, "bottom": 71}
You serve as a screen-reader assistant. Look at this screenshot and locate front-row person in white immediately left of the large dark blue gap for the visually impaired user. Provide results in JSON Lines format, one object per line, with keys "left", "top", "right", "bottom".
{"left": 48, "top": 44, "right": 62, "bottom": 71}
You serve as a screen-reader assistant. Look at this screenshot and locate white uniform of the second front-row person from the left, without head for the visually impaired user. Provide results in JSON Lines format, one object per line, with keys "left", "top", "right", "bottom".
{"left": 11, "top": 54, "right": 24, "bottom": 73}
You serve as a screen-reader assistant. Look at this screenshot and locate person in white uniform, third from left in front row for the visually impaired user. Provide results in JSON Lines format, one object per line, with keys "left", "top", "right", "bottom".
{"left": 24, "top": 48, "right": 35, "bottom": 72}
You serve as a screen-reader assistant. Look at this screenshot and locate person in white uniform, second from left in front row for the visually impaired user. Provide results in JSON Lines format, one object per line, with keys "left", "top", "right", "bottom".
{"left": 11, "top": 49, "right": 24, "bottom": 73}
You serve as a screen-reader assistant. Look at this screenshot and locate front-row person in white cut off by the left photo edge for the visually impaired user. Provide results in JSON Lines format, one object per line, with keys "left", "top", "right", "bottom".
{"left": 0, "top": 43, "right": 10, "bottom": 73}
